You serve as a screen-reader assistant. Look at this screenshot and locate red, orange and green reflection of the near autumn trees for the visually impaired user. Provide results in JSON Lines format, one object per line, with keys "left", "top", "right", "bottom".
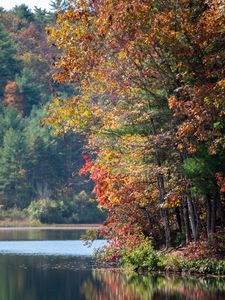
{"left": 81, "top": 270, "right": 225, "bottom": 300}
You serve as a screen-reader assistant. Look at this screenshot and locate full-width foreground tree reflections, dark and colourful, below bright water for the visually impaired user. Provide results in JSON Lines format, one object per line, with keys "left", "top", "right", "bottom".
{"left": 0, "top": 255, "right": 225, "bottom": 300}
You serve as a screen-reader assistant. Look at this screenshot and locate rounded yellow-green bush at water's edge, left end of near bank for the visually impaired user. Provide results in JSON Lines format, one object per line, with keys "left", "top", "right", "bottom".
{"left": 122, "top": 238, "right": 161, "bottom": 271}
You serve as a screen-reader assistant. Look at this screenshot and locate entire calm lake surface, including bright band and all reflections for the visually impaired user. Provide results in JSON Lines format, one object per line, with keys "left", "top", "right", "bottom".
{"left": 0, "top": 229, "right": 225, "bottom": 300}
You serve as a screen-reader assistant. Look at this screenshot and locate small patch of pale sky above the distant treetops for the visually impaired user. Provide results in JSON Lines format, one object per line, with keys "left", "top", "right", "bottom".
{"left": 0, "top": 0, "right": 50, "bottom": 10}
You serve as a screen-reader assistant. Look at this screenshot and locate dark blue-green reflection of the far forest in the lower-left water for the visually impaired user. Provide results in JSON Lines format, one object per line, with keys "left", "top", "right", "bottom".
{"left": 0, "top": 255, "right": 92, "bottom": 300}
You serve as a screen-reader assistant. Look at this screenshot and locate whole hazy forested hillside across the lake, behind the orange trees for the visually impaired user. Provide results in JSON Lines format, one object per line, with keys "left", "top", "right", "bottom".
{"left": 0, "top": 1, "right": 103, "bottom": 223}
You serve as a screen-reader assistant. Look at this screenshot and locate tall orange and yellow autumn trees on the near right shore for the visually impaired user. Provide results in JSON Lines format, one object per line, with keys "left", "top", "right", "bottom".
{"left": 46, "top": 0, "right": 225, "bottom": 257}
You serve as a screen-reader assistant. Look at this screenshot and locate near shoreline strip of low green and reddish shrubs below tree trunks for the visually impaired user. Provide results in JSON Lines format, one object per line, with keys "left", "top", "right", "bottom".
{"left": 121, "top": 240, "right": 225, "bottom": 277}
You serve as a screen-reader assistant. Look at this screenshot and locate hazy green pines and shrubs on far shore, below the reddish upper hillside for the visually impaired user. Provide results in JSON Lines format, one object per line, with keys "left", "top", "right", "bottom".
{"left": 0, "top": 102, "right": 105, "bottom": 223}
